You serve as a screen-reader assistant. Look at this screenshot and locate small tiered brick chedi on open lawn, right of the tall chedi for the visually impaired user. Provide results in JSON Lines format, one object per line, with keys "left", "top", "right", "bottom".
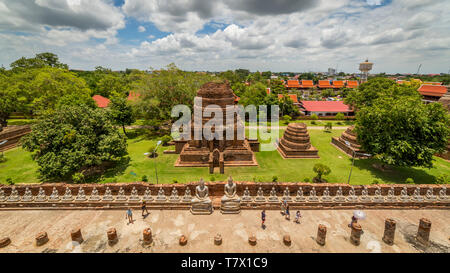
{"left": 278, "top": 123, "right": 319, "bottom": 158}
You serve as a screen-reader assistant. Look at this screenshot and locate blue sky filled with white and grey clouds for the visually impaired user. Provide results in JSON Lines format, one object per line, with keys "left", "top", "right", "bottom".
{"left": 0, "top": 0, "right": 450, "bottom": 73}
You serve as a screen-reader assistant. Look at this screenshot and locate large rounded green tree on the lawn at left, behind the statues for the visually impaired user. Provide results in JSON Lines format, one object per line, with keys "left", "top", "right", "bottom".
{"left": 22, "top": 106, "right": 127, "bottom": 180}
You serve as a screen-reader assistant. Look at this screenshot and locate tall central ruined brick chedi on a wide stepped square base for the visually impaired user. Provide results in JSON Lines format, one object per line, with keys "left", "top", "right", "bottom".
{"left": 175, "top": 82, "right": 258, "bottom": 173}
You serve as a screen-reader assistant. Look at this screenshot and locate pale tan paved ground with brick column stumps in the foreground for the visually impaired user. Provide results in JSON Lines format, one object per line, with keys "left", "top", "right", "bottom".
{"left": 0, "top": 210, "right": 450, "bottom": 253}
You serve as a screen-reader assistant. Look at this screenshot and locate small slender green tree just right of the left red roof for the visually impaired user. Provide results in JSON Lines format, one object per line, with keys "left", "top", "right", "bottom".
{"left": 108, "top": 93, "right": 136, "bottom": 135}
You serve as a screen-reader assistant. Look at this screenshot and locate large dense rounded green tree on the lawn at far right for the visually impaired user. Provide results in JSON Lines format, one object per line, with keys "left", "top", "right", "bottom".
{"left": 355, "top": 96, "right": 450, "bottom": 168}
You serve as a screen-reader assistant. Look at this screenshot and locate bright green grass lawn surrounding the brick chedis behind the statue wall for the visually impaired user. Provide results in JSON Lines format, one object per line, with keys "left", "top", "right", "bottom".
{"left": 0, "top": 130, "right": 450, "bottom": 185}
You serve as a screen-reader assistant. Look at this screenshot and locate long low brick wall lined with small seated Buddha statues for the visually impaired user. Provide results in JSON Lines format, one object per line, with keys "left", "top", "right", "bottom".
{"left": 0, "top": 182, "right": 450, "bottom": 209}
